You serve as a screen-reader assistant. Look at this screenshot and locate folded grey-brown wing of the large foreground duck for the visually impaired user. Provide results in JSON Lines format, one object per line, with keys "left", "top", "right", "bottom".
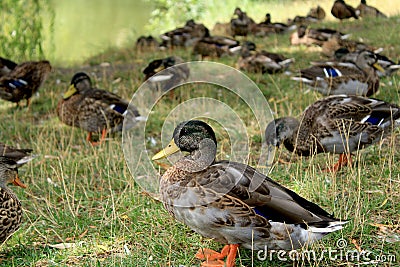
{"left": 198, "top": 161, "right": 335, "bottom": 224}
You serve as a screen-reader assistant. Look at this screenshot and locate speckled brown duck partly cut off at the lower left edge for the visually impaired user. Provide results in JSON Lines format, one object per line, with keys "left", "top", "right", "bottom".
{"left": 0, "top": 143, "right": 33, "bottom": 244}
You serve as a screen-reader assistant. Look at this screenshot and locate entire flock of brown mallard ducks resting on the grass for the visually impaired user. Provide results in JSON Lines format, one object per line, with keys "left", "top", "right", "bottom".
{"left": 0, "top": 0, "right": 400, "bottom": 267}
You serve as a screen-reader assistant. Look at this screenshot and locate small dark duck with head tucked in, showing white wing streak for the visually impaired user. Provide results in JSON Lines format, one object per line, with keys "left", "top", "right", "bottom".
{"left": 143, "top": 56, "right": 190, "bottom": 98}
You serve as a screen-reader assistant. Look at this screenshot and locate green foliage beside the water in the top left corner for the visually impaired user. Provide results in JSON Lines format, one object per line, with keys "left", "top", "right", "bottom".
{"left": 0, "top": 0, "right": 50, "bottom": 61}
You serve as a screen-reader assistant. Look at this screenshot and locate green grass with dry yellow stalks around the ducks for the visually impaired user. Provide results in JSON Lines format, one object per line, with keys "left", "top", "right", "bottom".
{"left": 0, "top": 9, "right": 400, "bottom": 266}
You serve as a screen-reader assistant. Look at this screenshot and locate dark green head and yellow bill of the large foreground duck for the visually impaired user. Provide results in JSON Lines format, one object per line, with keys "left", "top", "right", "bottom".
{"left": 152, "top": 120, "right": 217, "bottom": 160}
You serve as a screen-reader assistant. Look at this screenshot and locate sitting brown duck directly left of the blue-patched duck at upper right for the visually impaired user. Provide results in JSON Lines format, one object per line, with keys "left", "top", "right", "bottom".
{"left": 237, "top": 42, "right": 294, "bottom": 73}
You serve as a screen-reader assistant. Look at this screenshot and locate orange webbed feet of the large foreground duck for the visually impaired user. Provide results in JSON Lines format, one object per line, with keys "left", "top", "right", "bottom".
{"left": 196, "top": 244, "right": 239, "bottom": 267}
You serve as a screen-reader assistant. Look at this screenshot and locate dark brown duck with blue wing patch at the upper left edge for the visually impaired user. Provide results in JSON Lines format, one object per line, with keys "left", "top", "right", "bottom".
{"left": 0, "top": 60, "right": 51, "bottom": 107}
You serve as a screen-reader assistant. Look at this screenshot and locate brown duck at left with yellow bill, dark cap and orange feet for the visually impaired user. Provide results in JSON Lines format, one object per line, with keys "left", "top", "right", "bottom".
{"left": 57, "top": 72, "right": 143, "bottom": 146}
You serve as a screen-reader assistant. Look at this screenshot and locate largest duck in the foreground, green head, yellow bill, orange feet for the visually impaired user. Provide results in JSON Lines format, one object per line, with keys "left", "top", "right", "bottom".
{"left": 153, "top": 120, "right": 346, "bottom": 267}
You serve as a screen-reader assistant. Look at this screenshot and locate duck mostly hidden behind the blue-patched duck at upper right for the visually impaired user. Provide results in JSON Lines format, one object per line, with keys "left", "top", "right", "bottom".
{"left": 332, "top": 47, "right": 400, "bottom": 77}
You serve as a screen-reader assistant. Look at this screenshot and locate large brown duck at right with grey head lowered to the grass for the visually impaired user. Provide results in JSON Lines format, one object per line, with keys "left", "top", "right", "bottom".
{"left": 265, "top": 95, "right": 400, "bottom": 171}
